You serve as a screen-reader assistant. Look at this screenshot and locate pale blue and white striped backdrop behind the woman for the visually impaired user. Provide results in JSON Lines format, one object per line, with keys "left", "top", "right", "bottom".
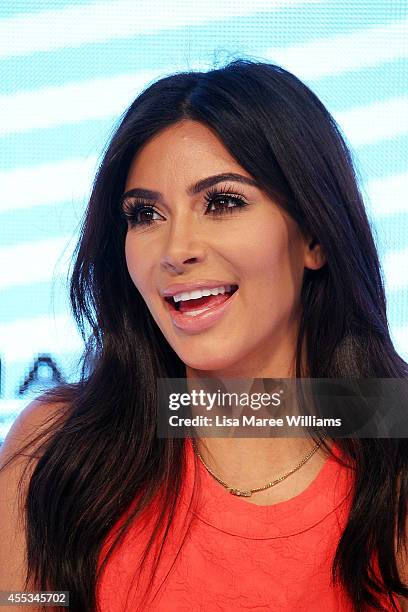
{"left": 0, "top": 0, "right": 408, "bottom": 438}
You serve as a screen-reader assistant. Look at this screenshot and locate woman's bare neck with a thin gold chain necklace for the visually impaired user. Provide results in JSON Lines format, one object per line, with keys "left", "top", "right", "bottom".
{"left": 186, "top": 338, "right": 326, "bottom": 505}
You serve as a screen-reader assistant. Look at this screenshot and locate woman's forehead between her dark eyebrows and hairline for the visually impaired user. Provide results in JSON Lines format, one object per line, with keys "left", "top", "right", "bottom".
{"left": 126, "top": 120, "right": 250, "bottom": 188}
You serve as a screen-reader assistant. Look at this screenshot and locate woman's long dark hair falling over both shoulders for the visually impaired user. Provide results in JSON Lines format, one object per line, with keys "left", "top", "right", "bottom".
{"left": 3, "top": 59, "right": 408, "bottom": 612}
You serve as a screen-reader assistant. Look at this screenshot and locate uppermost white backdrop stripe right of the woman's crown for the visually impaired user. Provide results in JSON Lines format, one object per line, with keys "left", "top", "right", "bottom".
{"left": 266, "top": 20, "right": 408, "bottom": 79}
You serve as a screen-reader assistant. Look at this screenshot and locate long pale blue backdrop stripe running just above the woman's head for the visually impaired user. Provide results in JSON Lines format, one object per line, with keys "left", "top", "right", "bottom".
{"left": 0, "top": 0, "right": 403, "bottom": 94}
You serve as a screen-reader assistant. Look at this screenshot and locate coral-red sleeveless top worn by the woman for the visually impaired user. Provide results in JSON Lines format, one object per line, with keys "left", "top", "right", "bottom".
{"left": 97, "top": 439, "right": 398, "bottom": 612}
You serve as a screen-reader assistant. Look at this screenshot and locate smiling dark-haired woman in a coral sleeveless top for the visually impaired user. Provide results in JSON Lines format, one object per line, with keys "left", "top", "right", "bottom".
{"left": 3, "top": 60, "right": 408, "bottom": 612}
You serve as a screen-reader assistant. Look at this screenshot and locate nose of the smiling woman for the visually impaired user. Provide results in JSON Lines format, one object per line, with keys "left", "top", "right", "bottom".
{"left": 161, "top": 215, "right": 206, "bottom": 274}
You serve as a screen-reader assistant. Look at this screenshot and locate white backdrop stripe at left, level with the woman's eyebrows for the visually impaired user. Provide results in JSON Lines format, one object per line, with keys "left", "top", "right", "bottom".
{"left": 0, "top": 156, "right": 97, "bottom": 214}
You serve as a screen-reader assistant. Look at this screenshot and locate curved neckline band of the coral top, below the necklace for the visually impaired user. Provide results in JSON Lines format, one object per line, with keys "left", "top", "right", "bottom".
{"left": 182, "top": 438, "right": 352, "bottom": 539}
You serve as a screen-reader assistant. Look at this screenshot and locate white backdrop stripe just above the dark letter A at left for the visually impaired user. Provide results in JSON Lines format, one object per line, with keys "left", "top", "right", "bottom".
{"left": 0, "top": 313, "right": 83, "bottom": 364}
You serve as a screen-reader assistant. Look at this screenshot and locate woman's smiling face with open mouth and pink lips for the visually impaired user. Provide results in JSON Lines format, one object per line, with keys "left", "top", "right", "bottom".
{"left": 123, "top": 120, "right": 322, "bottom": 378}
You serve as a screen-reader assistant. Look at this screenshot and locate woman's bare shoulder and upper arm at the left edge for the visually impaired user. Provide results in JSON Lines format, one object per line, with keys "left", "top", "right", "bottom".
{"left": 0, "top": 400, "right": 67, "bottom": 612}
